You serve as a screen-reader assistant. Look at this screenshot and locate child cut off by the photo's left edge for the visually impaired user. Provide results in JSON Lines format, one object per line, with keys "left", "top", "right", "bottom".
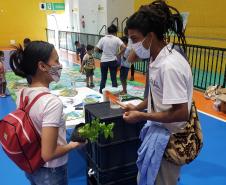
{"left": 0, "top": 51, "right": 6, "bottom": 97}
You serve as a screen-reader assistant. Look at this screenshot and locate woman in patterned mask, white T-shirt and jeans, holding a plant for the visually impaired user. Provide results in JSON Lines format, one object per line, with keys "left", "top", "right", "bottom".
{"left": 10, "top": 41, "right": 84, "bottom": 185}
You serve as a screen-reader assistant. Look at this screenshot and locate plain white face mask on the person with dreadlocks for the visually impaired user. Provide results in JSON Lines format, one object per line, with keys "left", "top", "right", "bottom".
{"left": 132, "top": 38, "right": 151, "bottom": 59}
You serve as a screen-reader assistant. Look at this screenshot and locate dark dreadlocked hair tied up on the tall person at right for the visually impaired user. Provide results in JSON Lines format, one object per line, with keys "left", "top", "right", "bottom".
{"left": 126, "top": 0, "right": 186, "bottom": 51}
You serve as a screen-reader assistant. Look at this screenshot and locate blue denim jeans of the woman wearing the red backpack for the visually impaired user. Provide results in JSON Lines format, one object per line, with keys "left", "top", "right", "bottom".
{"left": 25, "top": 165, "right": 68, "bottom": 185}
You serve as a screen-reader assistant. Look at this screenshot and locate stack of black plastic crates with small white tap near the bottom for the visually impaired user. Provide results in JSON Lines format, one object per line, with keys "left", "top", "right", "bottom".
{"left": 85, "top": 102, "right": 144, "bottom": 185}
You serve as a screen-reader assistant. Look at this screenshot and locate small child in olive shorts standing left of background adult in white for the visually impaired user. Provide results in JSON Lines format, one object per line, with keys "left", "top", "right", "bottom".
{"left": 81, "top": 45, "right": 95, "bottom": 88}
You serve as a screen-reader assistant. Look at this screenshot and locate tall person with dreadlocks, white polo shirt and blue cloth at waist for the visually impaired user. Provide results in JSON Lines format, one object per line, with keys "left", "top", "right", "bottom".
{"left": 123, "top": 0, "right": 193, "bottom": 185}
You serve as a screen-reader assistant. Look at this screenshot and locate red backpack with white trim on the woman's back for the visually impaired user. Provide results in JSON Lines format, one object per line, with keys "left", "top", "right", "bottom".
{"left": 0, "top": 91, "right": 49, "bottom": 173}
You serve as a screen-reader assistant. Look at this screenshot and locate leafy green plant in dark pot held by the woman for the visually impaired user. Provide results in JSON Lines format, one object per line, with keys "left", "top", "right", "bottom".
{"left": 71, "top": 119, "right": 114, "bottom": 142}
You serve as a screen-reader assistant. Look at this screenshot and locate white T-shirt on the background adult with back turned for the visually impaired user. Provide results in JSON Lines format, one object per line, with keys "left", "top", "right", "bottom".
{"left": 96, "top": 35, "right": 123, "bottom": 62}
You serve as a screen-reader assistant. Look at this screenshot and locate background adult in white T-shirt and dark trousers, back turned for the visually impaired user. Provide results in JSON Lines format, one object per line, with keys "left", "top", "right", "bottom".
{"left": 95, "top": 25, "right": 126, "bottom": 93}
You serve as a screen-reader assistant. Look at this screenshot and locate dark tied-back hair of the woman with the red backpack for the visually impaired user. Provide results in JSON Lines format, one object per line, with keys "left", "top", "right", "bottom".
{"left": 10, "top": 41, "right": 54, "bottom": 78}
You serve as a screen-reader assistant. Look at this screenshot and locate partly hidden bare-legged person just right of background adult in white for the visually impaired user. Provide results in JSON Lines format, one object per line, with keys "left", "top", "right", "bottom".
{"left": 120, "top": 37, "right": 131, "bottom": 95}
